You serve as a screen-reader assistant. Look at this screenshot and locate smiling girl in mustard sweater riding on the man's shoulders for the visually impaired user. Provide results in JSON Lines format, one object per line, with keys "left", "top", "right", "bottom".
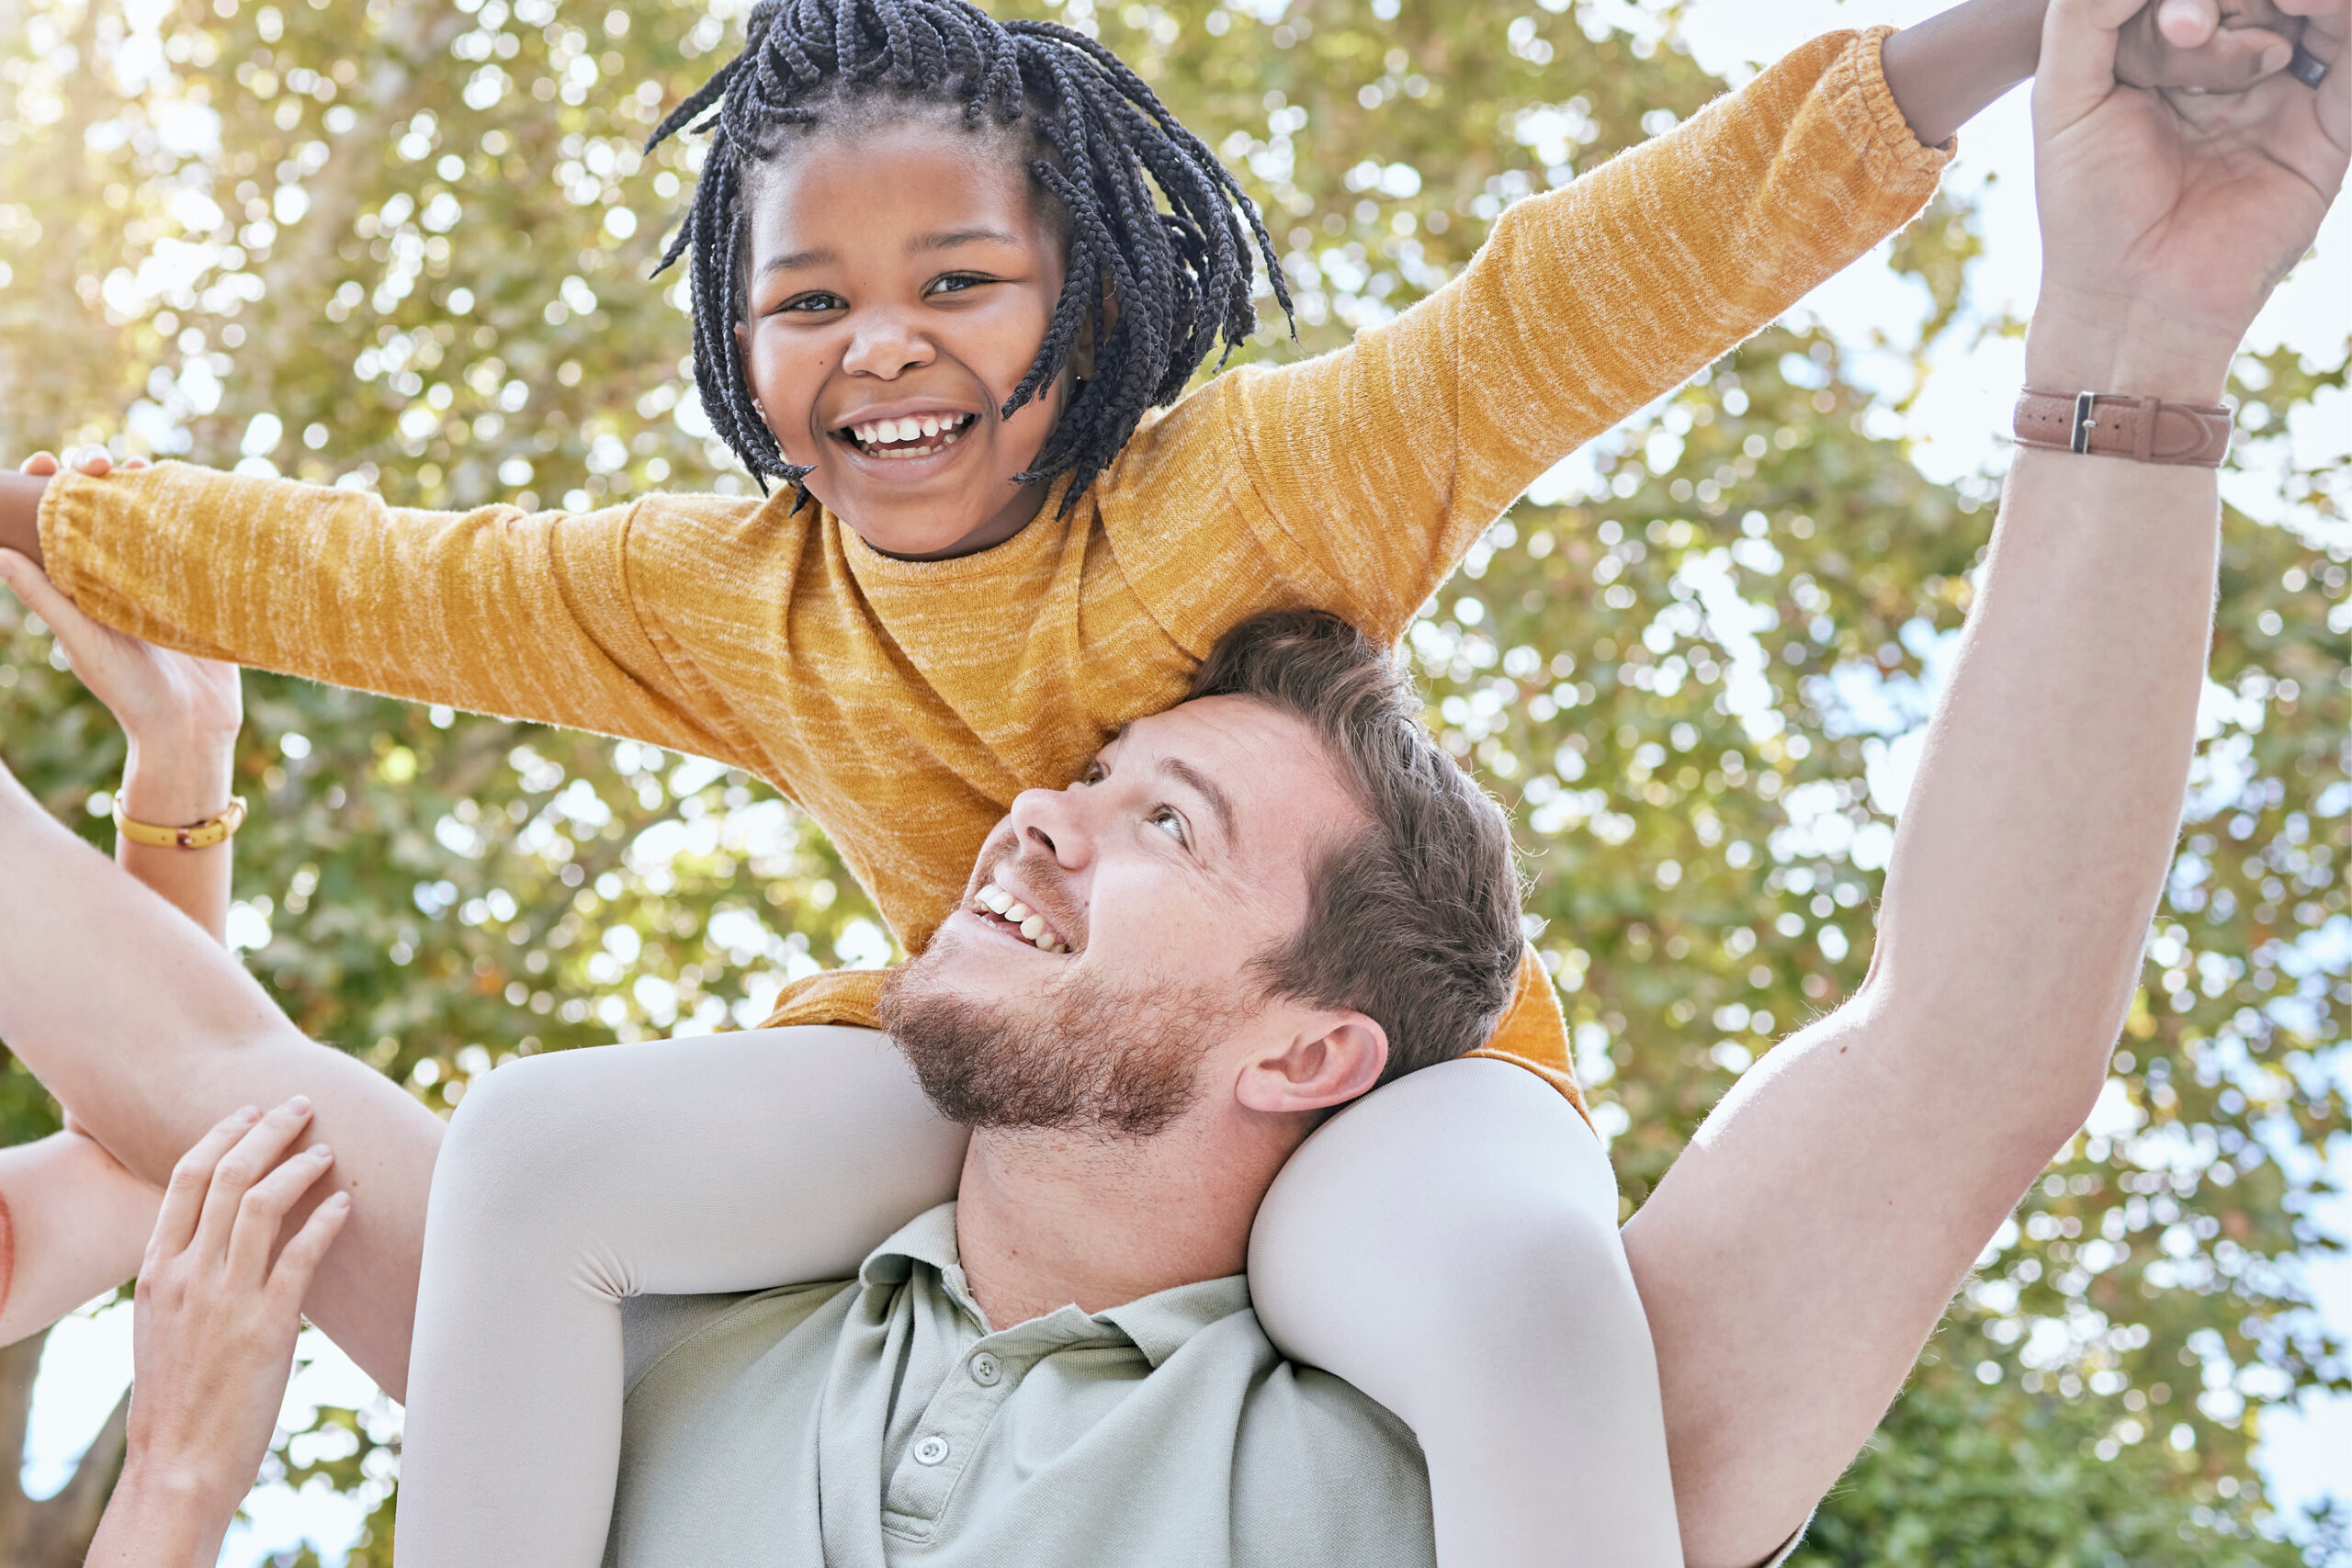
{"left": 0, "top": 0, "right": 2277, "bottom": 1563}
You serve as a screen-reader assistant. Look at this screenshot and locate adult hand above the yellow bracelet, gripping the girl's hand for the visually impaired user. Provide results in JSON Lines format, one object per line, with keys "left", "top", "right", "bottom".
{"left": 0, "top": 449, "right": 244, "bottom": 755}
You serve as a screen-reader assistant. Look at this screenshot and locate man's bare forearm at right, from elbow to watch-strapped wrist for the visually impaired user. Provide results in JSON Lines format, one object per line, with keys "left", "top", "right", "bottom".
{"left": 1870, "top": 321, "right": 2227, "bottom": 1114}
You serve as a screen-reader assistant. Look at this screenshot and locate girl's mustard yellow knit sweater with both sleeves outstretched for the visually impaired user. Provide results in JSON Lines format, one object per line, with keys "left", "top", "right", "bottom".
{"left": 40, "top": 28, "right": 1948, "bottom": 1098}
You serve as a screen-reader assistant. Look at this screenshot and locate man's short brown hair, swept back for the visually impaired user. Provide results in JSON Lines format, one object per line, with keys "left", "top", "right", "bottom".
{"left": 1188, "top": 609, "right": 1524, "bottom": 1084}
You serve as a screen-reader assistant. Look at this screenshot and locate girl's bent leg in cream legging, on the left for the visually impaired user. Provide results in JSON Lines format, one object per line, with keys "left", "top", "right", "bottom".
{"left": 398, "top": 1027, "right": 965, "bottom": 1568}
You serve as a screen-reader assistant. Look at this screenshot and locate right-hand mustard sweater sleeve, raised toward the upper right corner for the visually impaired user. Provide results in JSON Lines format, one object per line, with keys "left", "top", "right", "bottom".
{"left": 1204, "top": 28, "right": 1950, "bottom": 637}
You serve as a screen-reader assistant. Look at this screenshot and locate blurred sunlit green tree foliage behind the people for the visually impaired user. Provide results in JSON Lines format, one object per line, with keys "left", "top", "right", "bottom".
{"left": 0, "top": 0, "right": 2352, "bottom": 1565}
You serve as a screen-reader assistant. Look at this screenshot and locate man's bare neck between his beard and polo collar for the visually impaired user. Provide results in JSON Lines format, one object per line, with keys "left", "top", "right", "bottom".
{"left": 955, "top": 1117, "right": 1296, "bottom": 1328}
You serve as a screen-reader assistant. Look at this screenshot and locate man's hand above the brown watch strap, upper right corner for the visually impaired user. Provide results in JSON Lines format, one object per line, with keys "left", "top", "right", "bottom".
{"left": 2028, "top": 0, "right": 2352, "bottom": 402}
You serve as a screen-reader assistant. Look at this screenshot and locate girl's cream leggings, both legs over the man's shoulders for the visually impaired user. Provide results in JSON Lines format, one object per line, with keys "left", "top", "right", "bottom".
{"left": 398, "top": 1027, "right": 1681, "bottom": 1568}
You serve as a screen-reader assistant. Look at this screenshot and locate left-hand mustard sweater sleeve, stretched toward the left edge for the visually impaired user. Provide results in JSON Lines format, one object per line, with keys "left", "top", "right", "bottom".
{"left": 40, "top": 463, "right": 751, "bottom": 760}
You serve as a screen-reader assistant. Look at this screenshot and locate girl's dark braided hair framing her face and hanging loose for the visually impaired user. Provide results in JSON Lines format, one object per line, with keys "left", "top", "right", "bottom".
{"left": 647, "top": 0, "right": 1291, "bottom": 513}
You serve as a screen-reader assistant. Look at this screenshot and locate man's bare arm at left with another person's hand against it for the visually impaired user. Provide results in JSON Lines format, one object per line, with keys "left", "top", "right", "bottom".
{"left": 0, "top": 751, "right": 442, "bottom": 1399}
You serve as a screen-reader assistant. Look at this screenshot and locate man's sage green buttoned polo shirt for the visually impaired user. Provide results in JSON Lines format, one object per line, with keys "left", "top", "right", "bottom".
{"left": 605, "top": 1203, "right": 1437, "bottom": 1568}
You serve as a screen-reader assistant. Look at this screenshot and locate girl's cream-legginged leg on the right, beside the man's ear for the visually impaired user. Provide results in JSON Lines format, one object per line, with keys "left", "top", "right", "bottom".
{"left": 1249, "top": 1060, "right": 1681, "bottom": 1568}
